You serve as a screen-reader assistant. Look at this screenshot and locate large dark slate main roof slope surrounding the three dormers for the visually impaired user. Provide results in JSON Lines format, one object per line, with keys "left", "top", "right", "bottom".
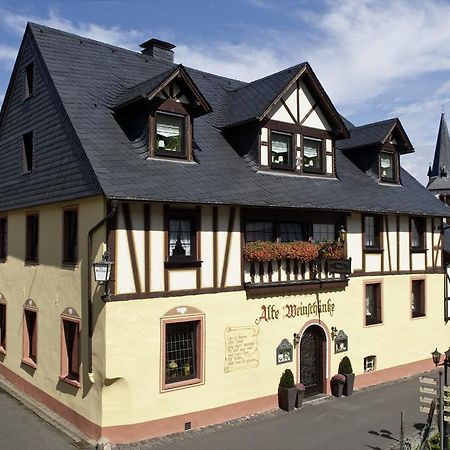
{"left": 1, "top": 24, "right": 448, "bottom": 216}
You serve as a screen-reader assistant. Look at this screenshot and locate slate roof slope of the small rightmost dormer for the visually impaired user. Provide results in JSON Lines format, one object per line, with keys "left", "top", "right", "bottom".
{"left": 336, "top": 119, "right": 398, "bottom": 150}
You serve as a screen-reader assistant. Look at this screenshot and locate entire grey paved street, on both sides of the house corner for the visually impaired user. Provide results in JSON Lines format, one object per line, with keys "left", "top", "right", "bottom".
{"left": 0, "top": 377, "right": 426, "bottom": 450}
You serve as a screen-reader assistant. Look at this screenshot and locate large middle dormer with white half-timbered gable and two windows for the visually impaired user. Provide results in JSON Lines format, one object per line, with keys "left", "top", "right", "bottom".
{"left": 223, "top": 63, "right": 349, "bottom": 176}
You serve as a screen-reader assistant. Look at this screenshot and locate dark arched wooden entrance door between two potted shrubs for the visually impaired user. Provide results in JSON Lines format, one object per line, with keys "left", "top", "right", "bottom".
{"left": 300, "top": 325, "right": 326, "bottom": 396}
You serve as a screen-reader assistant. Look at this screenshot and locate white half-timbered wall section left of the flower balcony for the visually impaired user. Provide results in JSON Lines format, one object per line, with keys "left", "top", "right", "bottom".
{"left": 112, "top": 203, "right": 241, "bottom": 297}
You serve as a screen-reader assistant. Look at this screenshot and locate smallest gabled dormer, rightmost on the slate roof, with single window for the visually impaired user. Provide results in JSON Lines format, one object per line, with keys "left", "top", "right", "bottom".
{"left": 338, "top": 119, "right": 414, "bottom": 185}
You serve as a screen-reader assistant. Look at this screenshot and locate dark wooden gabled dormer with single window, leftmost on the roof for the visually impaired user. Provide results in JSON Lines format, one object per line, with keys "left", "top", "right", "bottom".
{"left": 115, "top": 60, "right": 211, "bottom": 161}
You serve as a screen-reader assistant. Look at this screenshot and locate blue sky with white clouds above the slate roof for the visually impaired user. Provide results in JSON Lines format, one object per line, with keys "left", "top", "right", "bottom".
{"left": 0, "top": 0, "right": 450, "bottom": 184}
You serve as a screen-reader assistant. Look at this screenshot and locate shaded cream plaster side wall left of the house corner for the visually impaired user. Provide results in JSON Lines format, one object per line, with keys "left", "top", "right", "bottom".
{"left": 0, "top": 197, "right": 106, "bottom": 424}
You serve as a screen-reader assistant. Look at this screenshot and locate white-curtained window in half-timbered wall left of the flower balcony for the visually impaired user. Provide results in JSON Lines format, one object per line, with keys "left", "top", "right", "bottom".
{"left": 168, "top": 214, "right": 197, "bottom": 261}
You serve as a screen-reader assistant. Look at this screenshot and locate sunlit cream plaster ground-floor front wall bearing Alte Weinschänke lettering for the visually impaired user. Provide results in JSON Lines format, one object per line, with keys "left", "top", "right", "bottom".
{"left": 103, "top": 275, "right": 448, "bottom": 426}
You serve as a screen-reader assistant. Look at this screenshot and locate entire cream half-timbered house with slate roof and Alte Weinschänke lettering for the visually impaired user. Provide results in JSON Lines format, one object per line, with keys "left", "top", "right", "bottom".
{"left": 0, "top": 24, "right": 448, "bottom": 442}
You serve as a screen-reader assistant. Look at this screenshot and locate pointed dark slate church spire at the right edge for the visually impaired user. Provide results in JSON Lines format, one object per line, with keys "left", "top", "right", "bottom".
{"left": 427, "top": 113, "right": 450, "bottom": 191}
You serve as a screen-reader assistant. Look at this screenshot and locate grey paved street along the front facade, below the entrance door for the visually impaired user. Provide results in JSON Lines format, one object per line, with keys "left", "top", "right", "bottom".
{"left": 123, "top": 377, "right": 426, "bottom": 450}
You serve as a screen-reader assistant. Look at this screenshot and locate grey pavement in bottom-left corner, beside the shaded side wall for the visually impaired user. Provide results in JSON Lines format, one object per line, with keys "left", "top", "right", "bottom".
{"left": 0, "top": 389, "right": 75, "bottom": 450}
